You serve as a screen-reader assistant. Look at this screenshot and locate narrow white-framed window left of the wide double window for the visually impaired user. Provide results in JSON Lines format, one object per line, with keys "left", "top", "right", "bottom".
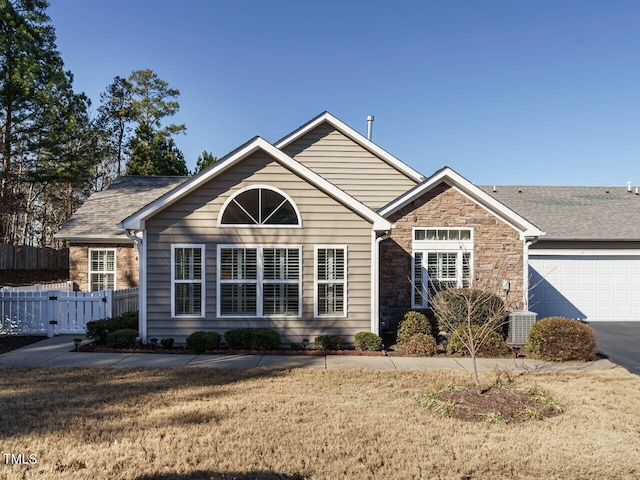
{"left": 171, "top": 245, "right": 205, "bottom": 317}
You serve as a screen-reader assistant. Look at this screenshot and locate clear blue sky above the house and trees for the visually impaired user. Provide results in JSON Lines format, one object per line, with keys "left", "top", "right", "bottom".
{"left": 48, "top": 0, "right": 640, "bottom": 186}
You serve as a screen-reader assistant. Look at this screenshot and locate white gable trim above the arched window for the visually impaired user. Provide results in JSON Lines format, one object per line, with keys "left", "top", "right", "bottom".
{"left": 118, "top": 137, "right": 391, "bottom": 231}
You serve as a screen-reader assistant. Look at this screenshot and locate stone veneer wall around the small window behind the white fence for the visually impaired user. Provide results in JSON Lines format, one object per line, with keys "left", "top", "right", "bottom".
{"left": 69, "top": 244, "right": 138, "bottom": 292}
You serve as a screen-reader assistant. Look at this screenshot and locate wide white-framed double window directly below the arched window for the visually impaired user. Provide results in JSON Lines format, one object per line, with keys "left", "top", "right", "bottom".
{"left": 218, "top": 245, "right": 302, "bottom": 317}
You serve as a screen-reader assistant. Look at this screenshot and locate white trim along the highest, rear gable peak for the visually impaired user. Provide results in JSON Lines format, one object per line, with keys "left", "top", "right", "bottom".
{"left": 275, "top": 112, "right": 425, "bottom": 182}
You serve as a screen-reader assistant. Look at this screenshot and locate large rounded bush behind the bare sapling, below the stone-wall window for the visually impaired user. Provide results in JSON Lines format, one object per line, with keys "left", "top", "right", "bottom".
{"left": 433, "top": 288, "right": 506, "bottom": 331}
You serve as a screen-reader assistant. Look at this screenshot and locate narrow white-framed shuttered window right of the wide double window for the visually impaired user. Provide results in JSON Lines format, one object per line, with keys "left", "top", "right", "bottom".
{"left": 315, "top": 246, "right": 347, "bottom": 317}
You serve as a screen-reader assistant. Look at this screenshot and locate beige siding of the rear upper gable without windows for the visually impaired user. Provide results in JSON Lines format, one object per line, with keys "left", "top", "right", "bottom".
{"left": 283, "top": 123, "right": 417, "bottom": 210}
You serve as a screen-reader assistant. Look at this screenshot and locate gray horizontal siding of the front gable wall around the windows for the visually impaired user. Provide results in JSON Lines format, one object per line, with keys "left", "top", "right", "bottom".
{"left": 146, "top": 152, "right": 372, "bottom": 343}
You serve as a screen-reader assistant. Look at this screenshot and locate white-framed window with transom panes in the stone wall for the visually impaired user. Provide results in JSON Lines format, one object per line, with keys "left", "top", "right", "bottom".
{"left": 411, "top": 228, "right": 473, "bottom": 308}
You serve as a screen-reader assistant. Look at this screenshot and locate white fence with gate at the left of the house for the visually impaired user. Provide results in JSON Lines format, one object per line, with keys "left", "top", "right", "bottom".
{"left": 0, "top": 288, "right": 138, "bottom": 337}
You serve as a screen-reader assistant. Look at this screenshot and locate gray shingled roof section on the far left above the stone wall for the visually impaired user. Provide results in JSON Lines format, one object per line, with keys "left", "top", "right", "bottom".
{"left": 55, "top": 176, "right": 188, "bottom": 243}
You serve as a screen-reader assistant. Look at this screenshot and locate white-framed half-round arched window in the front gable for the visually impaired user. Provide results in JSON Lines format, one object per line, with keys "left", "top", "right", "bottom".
{"left": 220, "top": 186, "right": 300, "bottom": 226}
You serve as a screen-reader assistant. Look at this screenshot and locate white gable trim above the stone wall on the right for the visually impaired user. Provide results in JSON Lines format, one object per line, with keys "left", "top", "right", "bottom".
{"left": 378, "top": 167, "right": 545, "bottom": 238}
